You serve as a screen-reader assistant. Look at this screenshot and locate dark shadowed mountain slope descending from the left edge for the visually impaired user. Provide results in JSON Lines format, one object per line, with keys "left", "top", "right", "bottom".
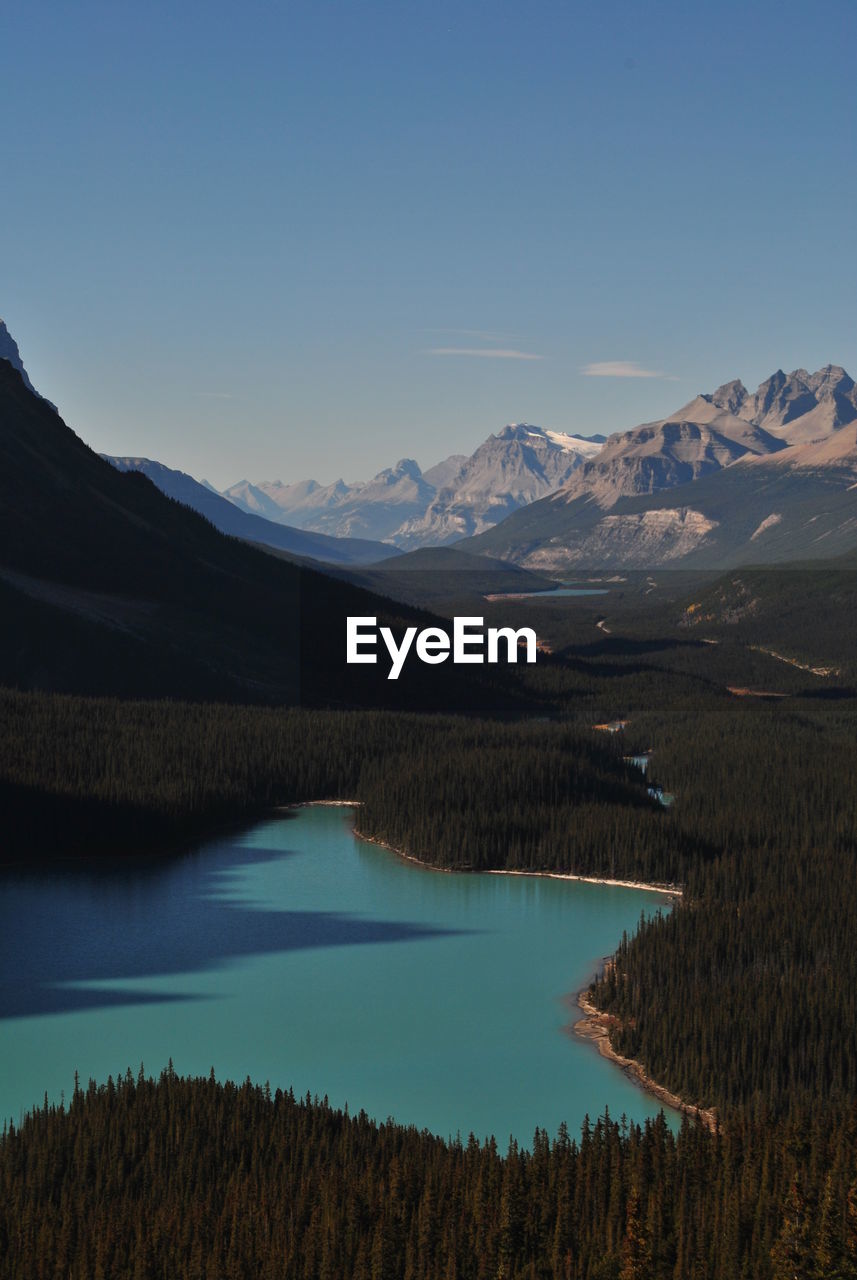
{"left": 0, "top": 361, "right": 534, "bottom": 709}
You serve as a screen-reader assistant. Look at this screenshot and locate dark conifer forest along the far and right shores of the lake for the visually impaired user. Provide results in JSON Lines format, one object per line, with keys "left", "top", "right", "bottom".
{"left": 0, "top": 645, "right": 857, "bottom": 1111}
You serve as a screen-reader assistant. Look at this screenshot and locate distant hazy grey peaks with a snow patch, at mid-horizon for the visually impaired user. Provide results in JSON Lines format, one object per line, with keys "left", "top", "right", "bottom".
{"left": 224, "top": 422, "right": 604, "bottom": 550}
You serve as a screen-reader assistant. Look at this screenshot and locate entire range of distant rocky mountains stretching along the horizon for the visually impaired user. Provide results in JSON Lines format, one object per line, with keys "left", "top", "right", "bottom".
{"left": 0, "top": 314, "right": 857, "bottom": 576}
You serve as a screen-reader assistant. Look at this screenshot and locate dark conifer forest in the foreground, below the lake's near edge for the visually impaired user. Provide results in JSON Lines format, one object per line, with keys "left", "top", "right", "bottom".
{"left": 0, "top": 1070, "right": 857, "bottom": 1280}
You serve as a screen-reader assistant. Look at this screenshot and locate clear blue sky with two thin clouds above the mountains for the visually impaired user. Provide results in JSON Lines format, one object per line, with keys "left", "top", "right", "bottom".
{"left": 0, "top": 0, "right": 857, "bottom": 485}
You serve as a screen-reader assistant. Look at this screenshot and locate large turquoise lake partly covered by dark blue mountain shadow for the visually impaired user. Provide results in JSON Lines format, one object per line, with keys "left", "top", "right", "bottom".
{"left": 0, "top": 806, "right": 669, "bottom": 1147}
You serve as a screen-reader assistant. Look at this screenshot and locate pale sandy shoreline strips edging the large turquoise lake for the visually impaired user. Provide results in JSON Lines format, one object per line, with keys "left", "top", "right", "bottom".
{"left": 288, "top": 800, "right": 716, "bottom": 1132}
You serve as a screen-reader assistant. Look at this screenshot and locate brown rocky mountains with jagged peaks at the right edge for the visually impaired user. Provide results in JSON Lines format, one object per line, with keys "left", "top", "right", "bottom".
{"left": 470, "top": 365, "right": 857, "bottom": 572}
